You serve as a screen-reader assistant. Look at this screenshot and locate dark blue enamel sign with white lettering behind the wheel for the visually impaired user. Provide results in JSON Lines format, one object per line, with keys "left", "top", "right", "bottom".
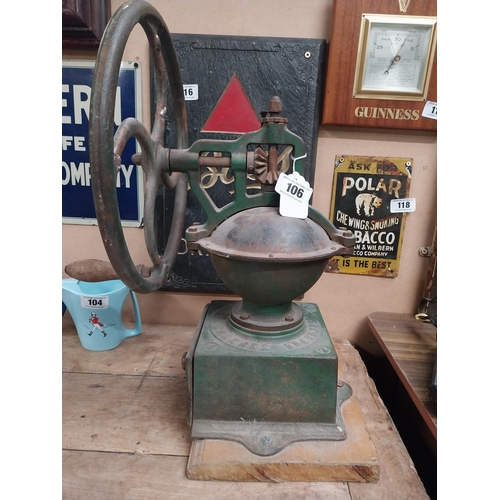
{"left": 62, "top": 61, "right": 143, "bottom": 227}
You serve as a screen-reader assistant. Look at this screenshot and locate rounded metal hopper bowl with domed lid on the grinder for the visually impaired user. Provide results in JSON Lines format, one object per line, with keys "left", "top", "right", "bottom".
{"left": 198, "top": 207, "right": 337, "bottom": 306}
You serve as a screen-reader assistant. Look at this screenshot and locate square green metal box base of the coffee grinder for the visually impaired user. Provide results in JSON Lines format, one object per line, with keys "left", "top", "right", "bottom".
{"left": 193, "top": 301, "right": 338, "bottom": 423}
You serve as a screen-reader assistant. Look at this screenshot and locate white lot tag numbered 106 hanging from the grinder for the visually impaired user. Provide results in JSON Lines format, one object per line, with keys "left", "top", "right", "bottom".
{"left": 274, "top": 172, "right": 313, "bottom": 219}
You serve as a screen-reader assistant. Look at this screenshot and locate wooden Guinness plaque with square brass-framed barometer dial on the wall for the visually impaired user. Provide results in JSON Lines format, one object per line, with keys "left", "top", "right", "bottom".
{"left": 322, "top": 0, "right": 437, "bottom": 130}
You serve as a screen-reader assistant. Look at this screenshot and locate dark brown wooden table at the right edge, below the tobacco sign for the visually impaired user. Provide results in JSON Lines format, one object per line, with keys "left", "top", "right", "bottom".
{"left": 367, "top": 312, "right": 437, "bottom": 499}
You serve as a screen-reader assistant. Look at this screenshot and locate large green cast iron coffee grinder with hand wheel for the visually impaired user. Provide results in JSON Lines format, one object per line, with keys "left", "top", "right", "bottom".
{"left": 66, "top": 0, "right": 354, "bottom": 456}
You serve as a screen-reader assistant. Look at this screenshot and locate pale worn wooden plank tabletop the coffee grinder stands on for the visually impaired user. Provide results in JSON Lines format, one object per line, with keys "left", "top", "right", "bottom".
{"left": 62, "top": 313, "right": 429, "bottom": 500}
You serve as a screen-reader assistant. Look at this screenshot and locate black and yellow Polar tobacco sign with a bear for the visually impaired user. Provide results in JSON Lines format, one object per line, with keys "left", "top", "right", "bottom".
{"left": 327, "top": 155, "right": 415, "bottom": 278}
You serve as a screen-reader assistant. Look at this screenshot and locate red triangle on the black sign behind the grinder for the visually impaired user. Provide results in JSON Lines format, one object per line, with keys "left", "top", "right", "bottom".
{"left": 201, "top": 74, "right": 260, "bottom": 134}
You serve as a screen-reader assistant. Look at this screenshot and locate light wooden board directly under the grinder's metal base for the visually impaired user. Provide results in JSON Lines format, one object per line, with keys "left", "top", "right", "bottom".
{"left": 187, "top": 388, "right": 380, "bottom": 483}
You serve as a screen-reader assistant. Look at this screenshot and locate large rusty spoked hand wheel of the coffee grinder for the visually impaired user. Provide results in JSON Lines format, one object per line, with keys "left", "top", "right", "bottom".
{"left": 89, "top": 0, "right": 187, "bottom": 293}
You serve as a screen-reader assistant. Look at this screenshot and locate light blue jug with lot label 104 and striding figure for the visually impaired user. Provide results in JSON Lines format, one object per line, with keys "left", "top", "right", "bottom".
{"left": 62, "top": 278, "right": 142, "bottom": 351}
